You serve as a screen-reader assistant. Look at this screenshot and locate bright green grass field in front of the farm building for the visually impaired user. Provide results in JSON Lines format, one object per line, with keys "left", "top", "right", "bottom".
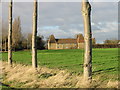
{"left": 2, "top": 48, "right": 118, "bottom": 80}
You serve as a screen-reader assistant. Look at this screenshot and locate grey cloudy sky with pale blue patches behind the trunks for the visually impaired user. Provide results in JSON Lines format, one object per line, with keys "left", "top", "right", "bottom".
{"left": 2, "top": 2, "right": 118, "bottom": 43}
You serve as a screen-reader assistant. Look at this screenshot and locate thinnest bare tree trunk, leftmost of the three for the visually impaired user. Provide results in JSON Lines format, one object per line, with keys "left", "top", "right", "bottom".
{"left": 8, "top": 0, "right": 12, "bottom": 65}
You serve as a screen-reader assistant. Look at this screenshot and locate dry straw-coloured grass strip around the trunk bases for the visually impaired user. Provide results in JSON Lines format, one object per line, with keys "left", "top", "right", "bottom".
{"left": 0, "top": 62, "right": 118, "bottom": 88}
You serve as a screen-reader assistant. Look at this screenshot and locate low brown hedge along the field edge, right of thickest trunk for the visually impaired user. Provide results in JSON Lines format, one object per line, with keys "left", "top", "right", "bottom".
{"left": 93, "top": 44, "right": 120, "bottom": 48}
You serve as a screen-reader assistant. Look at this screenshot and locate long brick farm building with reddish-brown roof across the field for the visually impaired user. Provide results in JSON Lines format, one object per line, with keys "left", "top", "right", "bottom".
{"left": 48, "top": 34, "right": 84, "bottom": 49}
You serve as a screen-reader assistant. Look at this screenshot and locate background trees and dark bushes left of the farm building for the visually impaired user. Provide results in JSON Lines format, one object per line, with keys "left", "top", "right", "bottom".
{"left": 2, "top": 17, "right": 45, "bottom": 51}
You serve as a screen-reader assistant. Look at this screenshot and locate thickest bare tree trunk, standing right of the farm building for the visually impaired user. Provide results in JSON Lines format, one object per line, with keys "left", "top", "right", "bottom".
{"left": 82, "top": 0, "right": 92, "bottom": 83}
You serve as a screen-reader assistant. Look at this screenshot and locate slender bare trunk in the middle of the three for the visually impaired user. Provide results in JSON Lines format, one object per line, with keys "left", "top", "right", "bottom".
{"left": 32, "top": 0, "right": 37, "bottom": 68}
